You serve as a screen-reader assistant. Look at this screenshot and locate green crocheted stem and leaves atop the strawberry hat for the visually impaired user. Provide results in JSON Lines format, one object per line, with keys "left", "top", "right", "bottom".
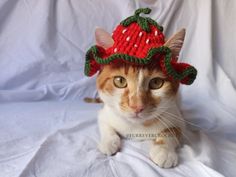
{"left": 120, "top": 8, "right": 163, "bottom": 32}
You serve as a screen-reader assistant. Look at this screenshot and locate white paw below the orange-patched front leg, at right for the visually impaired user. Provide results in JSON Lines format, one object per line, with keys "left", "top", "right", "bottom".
{"left": 150, "top": 147, "right": 178, "bottom": 168}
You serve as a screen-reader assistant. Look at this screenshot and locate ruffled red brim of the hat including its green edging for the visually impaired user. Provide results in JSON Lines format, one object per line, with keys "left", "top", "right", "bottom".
{"left": 84, "top": 45, "right": 197, "bottom": 85}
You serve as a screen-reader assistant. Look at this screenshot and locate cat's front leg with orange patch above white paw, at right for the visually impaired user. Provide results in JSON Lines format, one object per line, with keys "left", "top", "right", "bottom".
{"left": 150, "top": 128, "right": 181, "bottom": 168}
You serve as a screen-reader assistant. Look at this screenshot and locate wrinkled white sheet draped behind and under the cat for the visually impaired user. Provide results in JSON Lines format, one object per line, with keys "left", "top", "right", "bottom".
{"left": 0, "top": 0, "right": 236, "bottom": 177}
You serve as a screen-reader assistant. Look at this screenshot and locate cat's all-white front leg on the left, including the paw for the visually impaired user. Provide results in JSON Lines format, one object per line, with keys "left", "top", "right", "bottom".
{"left": 98, "top": 122, "right": 121, "bottom": 155}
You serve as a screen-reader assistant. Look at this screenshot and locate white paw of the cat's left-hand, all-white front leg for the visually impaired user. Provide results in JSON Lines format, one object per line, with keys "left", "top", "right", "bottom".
{"left": 98, "top": 135, "right": 121, "bottom": 155}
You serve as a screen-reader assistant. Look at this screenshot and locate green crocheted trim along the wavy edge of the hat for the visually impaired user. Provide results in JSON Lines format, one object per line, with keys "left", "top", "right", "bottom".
{"left": 84, "top": 45, "right": 197, "bottom": 85}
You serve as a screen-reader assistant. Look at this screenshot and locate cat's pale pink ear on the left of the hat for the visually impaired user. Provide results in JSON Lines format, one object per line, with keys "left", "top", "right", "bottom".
{"left": 95, "top": 28, "right": 114, "bottom": 49}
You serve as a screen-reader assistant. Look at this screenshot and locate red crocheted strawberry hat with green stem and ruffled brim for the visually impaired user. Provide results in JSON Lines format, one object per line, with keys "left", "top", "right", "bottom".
{"left": 84, "top": 8, "right": 197, "bottom": 85}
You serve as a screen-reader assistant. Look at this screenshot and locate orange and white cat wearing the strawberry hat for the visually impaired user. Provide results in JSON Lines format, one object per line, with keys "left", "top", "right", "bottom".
{"left": 95, "top": 28, "right": 185, "bottom": 168}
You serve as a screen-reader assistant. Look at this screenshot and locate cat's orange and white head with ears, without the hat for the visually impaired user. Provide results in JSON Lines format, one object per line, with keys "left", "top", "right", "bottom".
{"left": 95, "top": 28, "right": 185, "bottom": 122}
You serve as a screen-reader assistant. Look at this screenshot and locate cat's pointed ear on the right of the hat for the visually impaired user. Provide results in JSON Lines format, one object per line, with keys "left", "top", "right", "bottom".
{"left": 164, "top": 29, "right": 185, "bottom": 57}
